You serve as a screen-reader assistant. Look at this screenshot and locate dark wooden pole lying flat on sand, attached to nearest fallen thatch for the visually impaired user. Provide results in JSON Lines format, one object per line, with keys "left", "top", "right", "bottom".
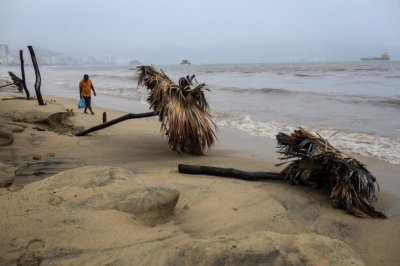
{"left": 178, "top": 164, "right": 283, "bottom": 181}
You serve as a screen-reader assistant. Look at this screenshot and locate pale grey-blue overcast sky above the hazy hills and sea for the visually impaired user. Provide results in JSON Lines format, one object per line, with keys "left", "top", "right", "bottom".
{"left": 0, "top": 0, "right": 400, "bottom": 64}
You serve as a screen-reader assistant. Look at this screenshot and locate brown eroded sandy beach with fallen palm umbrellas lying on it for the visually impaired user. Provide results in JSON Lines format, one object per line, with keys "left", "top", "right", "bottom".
{"left": 0, "top": 87, "right": 400, "bottom": 265}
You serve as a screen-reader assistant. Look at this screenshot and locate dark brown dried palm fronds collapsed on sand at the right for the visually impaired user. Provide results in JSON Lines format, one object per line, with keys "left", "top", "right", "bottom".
{"left": 276, "top": 128, "right": 386, "bottom": 218}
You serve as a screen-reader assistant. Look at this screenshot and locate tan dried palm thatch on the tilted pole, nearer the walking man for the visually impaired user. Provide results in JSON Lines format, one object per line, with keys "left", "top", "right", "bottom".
{"left": 136, "top": 66, "right": 215, "bottom": 155}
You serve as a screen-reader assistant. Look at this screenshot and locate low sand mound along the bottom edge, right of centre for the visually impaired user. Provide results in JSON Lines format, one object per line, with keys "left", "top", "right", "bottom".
{"left": 169, "top": 232, "right": 363, "bottom": 266}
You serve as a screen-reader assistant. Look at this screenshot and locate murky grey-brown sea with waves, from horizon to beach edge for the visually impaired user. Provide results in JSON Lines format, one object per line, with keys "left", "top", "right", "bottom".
{"left": 0, "top": 62, "right": 400, "bottom": 164}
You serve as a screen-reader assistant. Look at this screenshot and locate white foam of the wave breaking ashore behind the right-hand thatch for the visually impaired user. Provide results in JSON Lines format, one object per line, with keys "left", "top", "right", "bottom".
{"left": 217, "top": 116, "right": 400, "bottom": 164}
